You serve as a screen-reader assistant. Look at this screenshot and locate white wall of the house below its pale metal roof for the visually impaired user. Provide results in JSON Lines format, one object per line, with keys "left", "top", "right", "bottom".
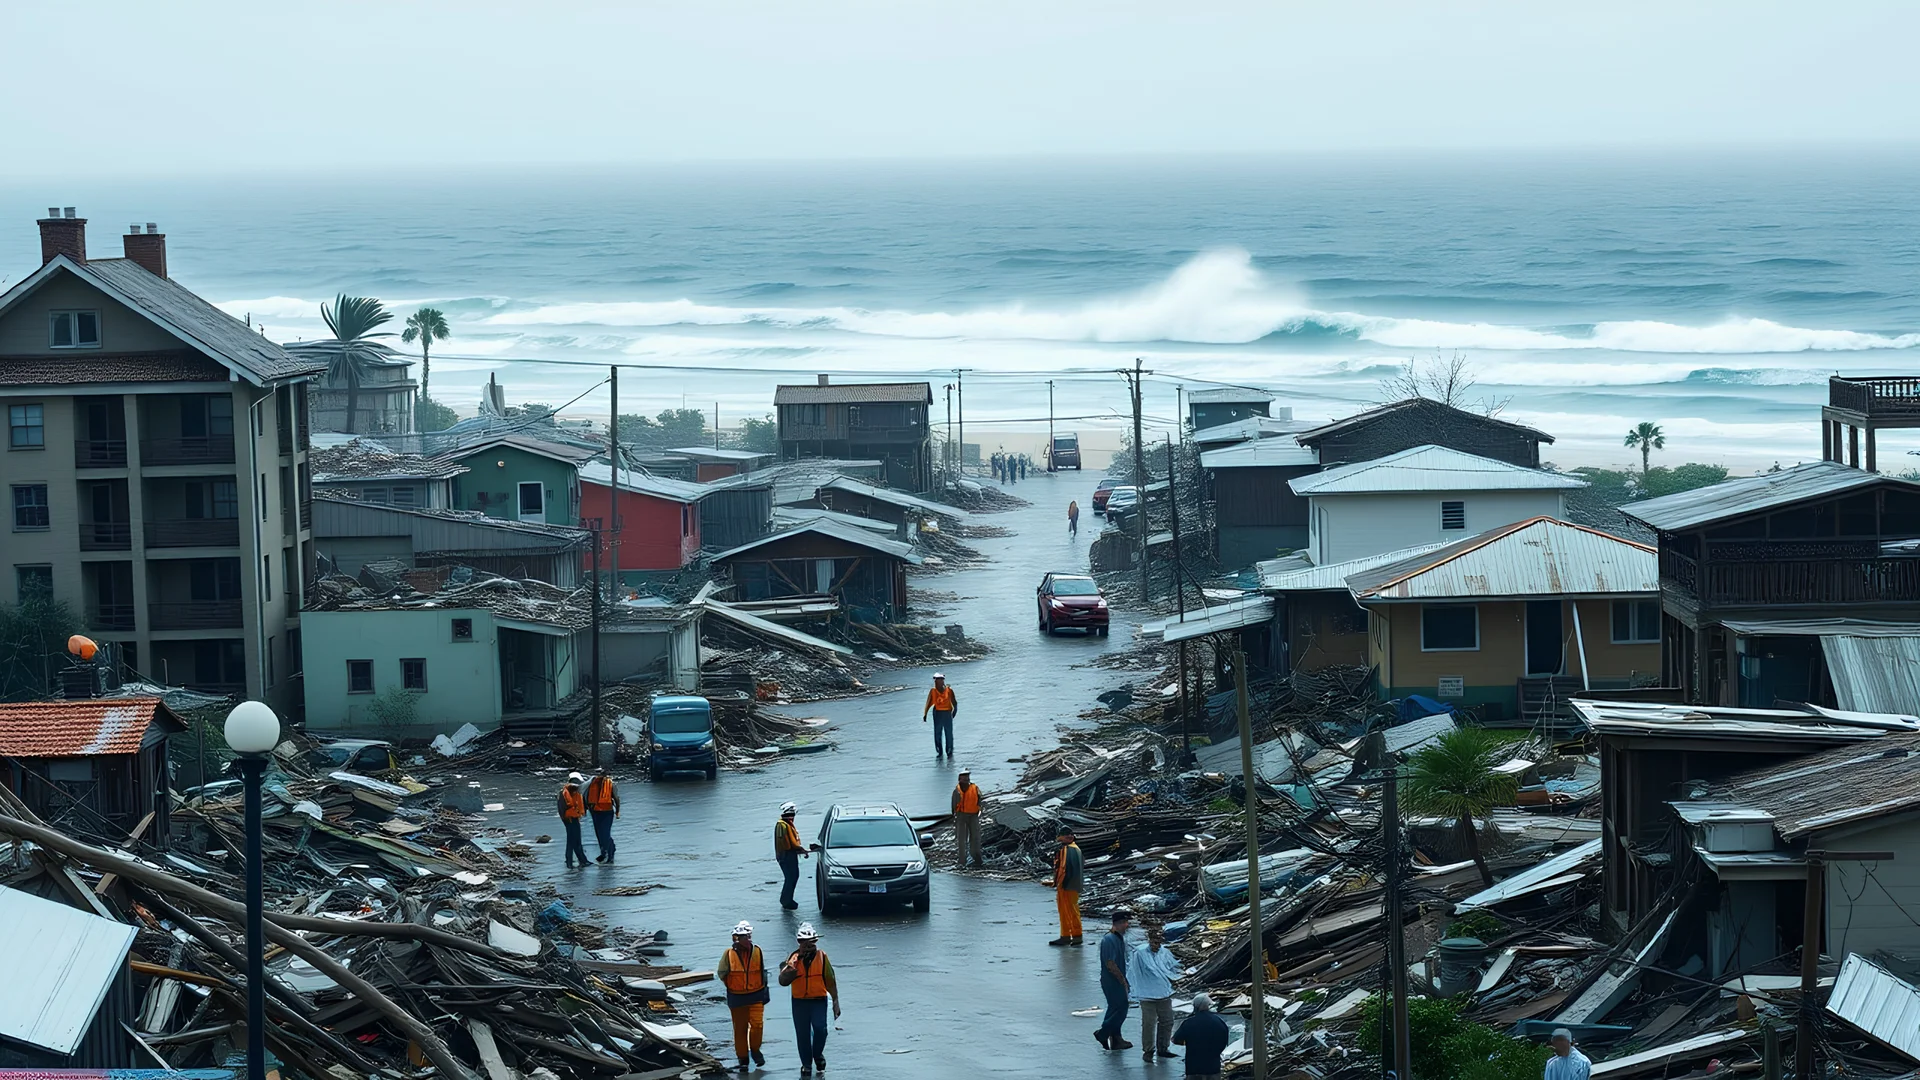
{"left": 1308, "top": 492, "right": 1567, "bottom": 565}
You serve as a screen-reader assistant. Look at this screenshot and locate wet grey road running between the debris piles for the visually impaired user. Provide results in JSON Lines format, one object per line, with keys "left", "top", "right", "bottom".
{"left": 488, "top": 471, "right": 1183, "bottom": 1078}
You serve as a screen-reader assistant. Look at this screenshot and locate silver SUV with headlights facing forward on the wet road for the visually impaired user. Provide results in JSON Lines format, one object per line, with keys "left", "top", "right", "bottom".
{"left": 814, "top": 803, "right": 933, "bottom": 915}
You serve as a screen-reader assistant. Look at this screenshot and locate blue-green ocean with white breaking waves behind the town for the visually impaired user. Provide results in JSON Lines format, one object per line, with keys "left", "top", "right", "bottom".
{"left": 0, "top": 150, "right": 1920, "bottom": 471}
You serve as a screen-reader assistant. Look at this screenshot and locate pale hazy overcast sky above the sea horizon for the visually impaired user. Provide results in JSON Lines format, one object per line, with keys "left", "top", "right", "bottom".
{"left": 0, "top": 0, "right": 1920, "bottom": 175}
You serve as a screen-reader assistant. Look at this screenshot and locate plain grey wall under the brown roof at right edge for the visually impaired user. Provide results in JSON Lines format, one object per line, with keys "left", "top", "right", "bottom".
{"left": 1822, "top": 817, "right": 1920, "bottom": 957}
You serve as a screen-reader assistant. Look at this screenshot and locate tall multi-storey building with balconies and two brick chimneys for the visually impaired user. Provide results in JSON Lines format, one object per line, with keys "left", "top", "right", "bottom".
{"left": 0, "top": 208, "right": 319, "bottom": 715}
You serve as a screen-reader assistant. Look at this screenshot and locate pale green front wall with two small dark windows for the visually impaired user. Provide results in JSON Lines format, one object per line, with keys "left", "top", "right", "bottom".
{"left": 301, "top": 609, "right": 501, "bottom": 736}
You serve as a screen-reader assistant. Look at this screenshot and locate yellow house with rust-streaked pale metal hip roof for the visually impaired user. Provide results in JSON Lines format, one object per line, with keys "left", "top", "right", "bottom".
{"left": 1346, "top": 517, "right": 1661, "bottom": 721}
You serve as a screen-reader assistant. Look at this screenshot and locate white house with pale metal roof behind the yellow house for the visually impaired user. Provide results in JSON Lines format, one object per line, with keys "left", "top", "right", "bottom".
{"left": 1288, "top": 446, "right": 1586, "bottom": 565}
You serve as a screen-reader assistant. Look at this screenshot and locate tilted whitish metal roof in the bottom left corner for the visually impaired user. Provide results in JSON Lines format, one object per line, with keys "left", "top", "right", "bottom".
{"left": 0, "top": 888, "right": 134, "bottom": 1055}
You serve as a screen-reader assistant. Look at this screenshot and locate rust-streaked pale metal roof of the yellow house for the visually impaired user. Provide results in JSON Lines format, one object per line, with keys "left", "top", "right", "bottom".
{"left": 1346, "top": 517, "right": 1661, "bottom": 603}
